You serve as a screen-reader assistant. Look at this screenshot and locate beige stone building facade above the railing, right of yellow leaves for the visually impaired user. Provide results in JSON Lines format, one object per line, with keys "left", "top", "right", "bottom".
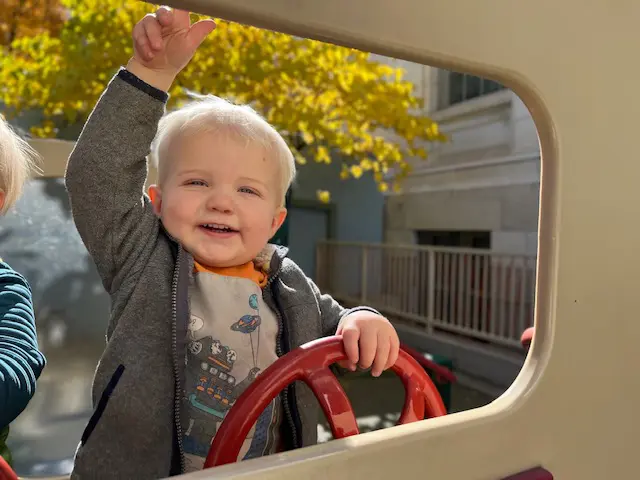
{"left": 384, "top": 60, "right": 540, "bottom": 255}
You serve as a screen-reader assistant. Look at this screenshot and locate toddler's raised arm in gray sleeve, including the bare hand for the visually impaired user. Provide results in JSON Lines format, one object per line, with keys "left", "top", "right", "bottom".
{"left": 66, "top": 7, "right": 214, "bottom": 293}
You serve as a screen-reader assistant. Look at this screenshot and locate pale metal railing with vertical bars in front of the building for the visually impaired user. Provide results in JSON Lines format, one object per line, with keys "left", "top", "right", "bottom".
{"left": 316, "top": 242, "right": 536, "bottom": 348}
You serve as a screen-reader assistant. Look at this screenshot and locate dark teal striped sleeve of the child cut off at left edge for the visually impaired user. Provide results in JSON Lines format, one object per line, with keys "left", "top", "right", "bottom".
{"left": 0, "top": 264, "right": 45, "bottom": 430}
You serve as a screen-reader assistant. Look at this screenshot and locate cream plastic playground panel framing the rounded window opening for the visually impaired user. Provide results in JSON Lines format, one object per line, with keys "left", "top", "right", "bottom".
{"left": 33, "top": 0, "right": 640, "bottom": 480}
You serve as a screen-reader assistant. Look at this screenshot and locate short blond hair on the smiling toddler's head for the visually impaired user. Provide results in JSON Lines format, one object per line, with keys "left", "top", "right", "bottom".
{"left": 153, "top": 95, "right": 296, "bottom": 204}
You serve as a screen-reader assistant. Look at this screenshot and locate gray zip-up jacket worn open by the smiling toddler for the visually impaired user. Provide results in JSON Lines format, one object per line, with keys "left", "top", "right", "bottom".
{"left": 66, "top": 69, "right": 376, "bottom": 480}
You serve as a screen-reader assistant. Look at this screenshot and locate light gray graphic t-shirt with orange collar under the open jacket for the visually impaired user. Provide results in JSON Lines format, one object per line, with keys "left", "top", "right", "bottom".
{"left": 182, "top": 262, "right": 281, "bottom": 472}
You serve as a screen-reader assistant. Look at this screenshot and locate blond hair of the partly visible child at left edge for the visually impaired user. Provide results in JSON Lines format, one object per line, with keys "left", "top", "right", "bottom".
{"left": 0, "top": 115, "right": 39, "bottom": 214}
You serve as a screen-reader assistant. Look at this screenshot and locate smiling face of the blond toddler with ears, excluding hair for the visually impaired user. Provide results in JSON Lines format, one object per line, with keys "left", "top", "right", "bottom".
{"left": 149, "top": 133, "right": 286, "bottom": 267}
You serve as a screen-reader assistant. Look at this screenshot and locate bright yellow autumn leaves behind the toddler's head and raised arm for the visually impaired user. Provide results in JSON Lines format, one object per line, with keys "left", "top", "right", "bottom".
{"left": 0, "top": 0, "right": 445, "bottom": 195}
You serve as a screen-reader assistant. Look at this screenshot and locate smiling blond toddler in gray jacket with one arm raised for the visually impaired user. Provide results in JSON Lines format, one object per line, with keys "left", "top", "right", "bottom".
{"left": 66, "top": 7, "right": 399, "bottom": 479}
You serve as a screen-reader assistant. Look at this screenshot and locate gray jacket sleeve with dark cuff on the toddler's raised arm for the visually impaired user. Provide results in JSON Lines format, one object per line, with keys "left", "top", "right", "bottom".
{"left": 65, "top": 69, "right": 168, "bottom": 293}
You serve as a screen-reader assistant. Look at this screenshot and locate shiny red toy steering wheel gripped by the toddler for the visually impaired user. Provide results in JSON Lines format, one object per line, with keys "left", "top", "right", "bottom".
{"left": 204, "top": 336, "right": 447, "bottom": 468}
